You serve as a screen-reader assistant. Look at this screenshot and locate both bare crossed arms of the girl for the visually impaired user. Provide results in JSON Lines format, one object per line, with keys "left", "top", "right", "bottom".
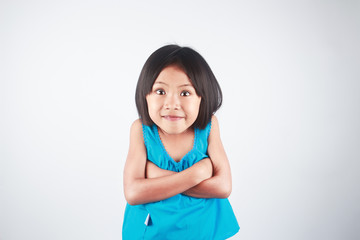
{"left": 124, "top": 116, "right": 231, "bottom": 205}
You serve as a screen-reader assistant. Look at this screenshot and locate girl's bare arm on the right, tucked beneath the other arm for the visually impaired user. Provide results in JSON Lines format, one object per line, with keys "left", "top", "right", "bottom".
{"left": 147, "top": 116, "right": 232, "bottom": 198}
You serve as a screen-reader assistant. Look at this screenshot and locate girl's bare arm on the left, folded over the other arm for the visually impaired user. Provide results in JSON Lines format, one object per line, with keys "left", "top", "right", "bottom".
{"left": 124, "top": 120, "right": 211, "bottom": 205}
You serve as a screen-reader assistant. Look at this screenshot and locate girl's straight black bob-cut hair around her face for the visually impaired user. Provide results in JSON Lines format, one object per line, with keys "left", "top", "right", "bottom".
{"left": 135, "top": 45, "right": 222, "bottom": 129}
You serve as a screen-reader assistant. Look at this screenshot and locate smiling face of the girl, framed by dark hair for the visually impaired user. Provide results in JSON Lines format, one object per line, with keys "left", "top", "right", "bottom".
{"left": 146, "top": 66, "right": 201, "bottom": 134}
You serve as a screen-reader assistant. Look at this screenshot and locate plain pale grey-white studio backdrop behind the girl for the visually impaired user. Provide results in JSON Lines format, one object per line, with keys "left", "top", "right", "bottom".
{"left": 0, "top": 0, "right": 360, "bottom": 240}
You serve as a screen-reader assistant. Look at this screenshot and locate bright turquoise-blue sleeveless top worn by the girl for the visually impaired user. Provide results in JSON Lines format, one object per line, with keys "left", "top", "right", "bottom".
{"left": 122, "top": 122, "right": 240, "bottom": 240}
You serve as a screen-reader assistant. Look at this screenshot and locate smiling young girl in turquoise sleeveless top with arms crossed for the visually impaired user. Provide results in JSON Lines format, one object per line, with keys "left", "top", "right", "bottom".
{"left": 122, "top": 45, "right": 239, "bottom": 240}
